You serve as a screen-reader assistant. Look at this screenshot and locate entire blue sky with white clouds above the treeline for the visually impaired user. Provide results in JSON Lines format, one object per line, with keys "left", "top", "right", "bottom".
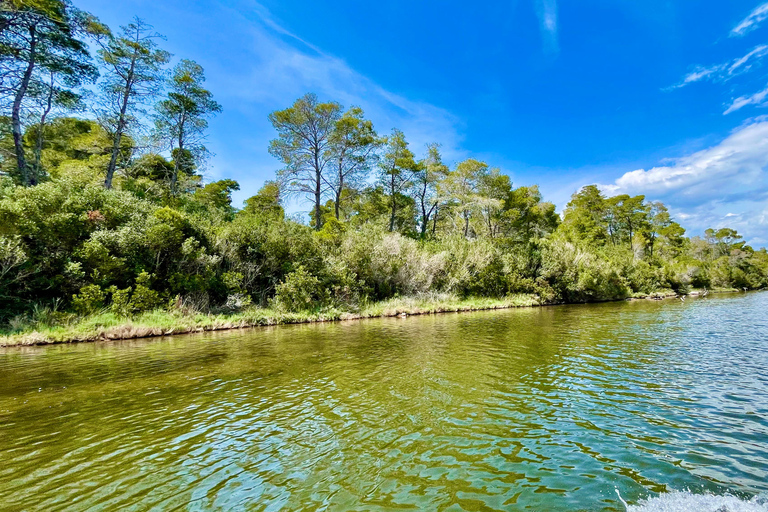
{"left": 75, "top": 0, "right": 768, "bottom": 247}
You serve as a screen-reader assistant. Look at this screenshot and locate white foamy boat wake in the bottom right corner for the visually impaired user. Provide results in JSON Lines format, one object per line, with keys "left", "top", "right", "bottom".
{"left": 617, "top": 491, "right": 768, "bottom": 512}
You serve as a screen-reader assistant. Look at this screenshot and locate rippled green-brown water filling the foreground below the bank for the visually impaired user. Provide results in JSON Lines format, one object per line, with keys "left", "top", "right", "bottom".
{"left": 0, "top": 293, "right": 768, "bottom": 512}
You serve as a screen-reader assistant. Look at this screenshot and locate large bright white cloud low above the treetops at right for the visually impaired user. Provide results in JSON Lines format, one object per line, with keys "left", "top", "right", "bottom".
{"left": 601, "top": 117, "right": 768, "bottom": 240}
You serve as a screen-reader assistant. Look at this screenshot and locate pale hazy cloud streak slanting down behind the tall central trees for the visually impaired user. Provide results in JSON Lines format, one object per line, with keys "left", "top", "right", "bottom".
{"left": 195, "top": 0, "right": 466, "bottom": 208}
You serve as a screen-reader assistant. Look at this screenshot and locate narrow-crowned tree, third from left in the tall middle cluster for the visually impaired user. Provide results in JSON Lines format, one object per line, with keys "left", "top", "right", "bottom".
{"left": 379, "top": 129, "right": 417, "bottom": 231}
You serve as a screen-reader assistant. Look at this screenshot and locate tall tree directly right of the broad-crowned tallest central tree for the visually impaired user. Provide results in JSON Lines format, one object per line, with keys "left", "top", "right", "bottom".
{"left": 328, "top": 107, "right": 380, "bottom": 220}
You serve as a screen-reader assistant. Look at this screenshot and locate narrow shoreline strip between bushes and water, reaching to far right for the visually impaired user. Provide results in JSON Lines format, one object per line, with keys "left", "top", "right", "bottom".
{"left": 0, "top": 289, "right": 752, "bottom": 348}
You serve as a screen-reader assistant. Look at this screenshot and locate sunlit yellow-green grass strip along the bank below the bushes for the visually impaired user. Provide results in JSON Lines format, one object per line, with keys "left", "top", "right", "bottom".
{"left": 0, "top": 294, "right": 539, "bottom": 346}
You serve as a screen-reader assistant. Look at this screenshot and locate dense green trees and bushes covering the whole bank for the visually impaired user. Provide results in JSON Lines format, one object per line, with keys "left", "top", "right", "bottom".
{"left": 0, "top": 0, "right": 768, "bottom": 340}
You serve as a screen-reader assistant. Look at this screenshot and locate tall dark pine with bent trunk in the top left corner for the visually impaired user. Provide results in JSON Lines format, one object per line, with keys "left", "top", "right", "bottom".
{"left": 0, "top": 0, "right": 99, "bottom": 186}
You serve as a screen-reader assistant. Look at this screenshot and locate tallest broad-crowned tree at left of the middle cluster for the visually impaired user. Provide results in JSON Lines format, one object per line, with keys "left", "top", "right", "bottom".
{"left": 269, "top": 93, "right": 341, "bottom": 231}
